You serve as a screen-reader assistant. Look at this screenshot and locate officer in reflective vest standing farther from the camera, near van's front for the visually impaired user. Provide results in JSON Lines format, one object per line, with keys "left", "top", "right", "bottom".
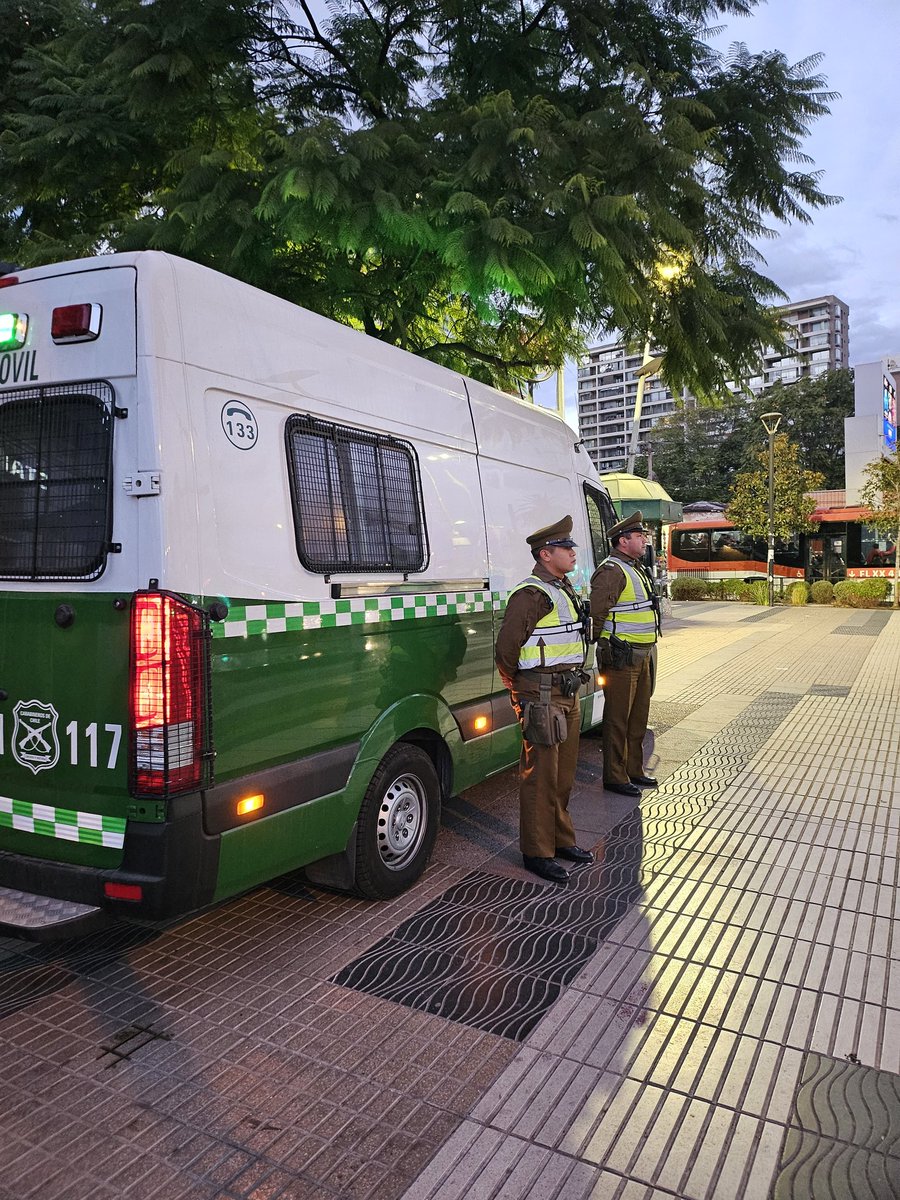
{"left": 590, "top": 511, "right": 660, "bottom": 796}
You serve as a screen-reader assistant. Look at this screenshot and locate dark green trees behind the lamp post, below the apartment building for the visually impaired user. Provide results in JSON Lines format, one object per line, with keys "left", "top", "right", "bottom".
{"left": 649, "top": 371, "right": 853, "bottom": 504}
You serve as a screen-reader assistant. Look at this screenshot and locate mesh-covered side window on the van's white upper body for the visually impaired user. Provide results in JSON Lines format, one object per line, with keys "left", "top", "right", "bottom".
{"left": 286, "top": 415, "right": 428, "bottom": 575}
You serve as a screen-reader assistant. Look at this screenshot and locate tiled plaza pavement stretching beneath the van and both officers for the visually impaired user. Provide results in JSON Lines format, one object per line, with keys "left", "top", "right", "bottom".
{"left": 0, "top": 604, "right": 900, "bottom": 1200}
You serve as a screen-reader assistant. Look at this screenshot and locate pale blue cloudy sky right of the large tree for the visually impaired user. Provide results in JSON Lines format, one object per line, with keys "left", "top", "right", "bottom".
{"left": 538, "top": 0, "right": 900, "bottom": 426}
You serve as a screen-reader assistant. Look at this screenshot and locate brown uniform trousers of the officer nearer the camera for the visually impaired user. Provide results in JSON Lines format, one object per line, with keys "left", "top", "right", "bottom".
{"left": 511, "top": 677, "right": 581, "bottom": 858}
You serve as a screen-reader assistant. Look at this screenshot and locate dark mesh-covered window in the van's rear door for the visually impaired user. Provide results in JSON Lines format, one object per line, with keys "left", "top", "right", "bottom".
{"left": 0, "top": 383, "right": 113, "bottom": 580}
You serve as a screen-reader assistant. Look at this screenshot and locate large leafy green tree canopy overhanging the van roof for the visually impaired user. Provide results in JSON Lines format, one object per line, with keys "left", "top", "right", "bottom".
{"left": 0, "top": 0, "right": 833, "bottom": 394}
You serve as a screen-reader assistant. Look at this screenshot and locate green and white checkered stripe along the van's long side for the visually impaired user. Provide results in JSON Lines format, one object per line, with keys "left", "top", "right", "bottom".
{"left": 212, "top": 592, "right": 508, "bottom": 637}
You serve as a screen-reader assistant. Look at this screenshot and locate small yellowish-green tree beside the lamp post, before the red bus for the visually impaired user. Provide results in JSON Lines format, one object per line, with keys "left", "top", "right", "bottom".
{"left": 725, "top": 433, "right": 823, "bottom": 539}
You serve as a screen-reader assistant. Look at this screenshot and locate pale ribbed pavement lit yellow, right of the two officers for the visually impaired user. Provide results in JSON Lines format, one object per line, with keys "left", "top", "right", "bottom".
{"left": 406, "top": 605, "right": 900, "bottom": 1200}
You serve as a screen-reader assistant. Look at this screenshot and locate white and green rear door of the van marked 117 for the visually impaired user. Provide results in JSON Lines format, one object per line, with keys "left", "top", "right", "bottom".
{"left": 0, "top": 260, "right": 138, "bottom": 936}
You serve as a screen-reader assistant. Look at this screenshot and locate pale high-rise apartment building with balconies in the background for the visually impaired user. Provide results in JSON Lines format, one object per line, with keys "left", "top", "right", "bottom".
{"left": 578, "top": 296, "right": 850, "bottom": 472}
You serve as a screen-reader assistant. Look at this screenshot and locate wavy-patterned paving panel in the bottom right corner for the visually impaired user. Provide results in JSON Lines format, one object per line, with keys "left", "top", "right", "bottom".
{"left": 774, "top": 1054, "right": 900, "bottom": 1200}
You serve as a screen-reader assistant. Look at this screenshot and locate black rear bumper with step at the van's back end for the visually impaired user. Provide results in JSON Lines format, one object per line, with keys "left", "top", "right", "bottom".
{"left": 0, "top": 794, "right": 220, "bottom": 938}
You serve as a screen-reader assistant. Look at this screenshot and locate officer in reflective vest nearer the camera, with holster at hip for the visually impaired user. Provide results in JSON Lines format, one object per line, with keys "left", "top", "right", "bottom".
{"left": 496, "top": 516, "right": 593, "bottom": 883}
